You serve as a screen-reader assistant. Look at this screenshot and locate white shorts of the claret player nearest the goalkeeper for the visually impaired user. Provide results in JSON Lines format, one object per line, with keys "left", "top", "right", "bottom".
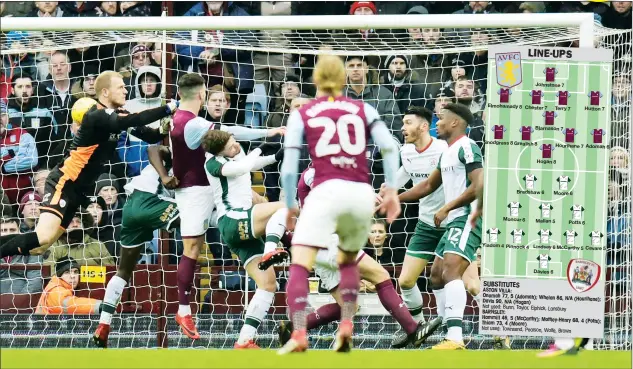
{"left": 175, "top": 186, "right": 215, "bottom": 238}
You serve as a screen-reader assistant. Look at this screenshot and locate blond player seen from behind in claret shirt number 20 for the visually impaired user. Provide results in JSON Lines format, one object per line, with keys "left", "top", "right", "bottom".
{"left": 279, "top": 55, "right": 400, "bottom": 354}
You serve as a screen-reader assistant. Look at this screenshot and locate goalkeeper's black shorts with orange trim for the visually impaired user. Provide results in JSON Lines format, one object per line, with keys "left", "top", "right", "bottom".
{"left": 40, "top": 169, "right": 86, "bottom": 228}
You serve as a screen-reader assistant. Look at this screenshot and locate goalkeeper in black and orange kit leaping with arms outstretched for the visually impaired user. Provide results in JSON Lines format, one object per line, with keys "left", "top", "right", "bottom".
{"left": 0, "top": 71, "right": 177, "bottom": 258}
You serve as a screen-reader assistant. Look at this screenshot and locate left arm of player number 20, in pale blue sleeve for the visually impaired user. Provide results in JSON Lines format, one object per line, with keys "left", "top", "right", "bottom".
{"left": 281, "top": 110, "right": 304, "bottom": 209}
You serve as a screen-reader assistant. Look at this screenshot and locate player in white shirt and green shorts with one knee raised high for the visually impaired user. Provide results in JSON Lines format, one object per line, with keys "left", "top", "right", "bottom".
{"left": 202, "top": 131, "right": 288, "bottom": 349}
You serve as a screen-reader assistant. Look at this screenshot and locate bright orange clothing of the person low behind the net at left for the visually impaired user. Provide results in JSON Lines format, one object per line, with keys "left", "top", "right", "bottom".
{"left": 35, "top": 277, "right": 101, "bottom": 315}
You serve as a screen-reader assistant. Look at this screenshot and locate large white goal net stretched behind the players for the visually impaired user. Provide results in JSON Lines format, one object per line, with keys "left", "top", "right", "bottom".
{"left": 0, "top": 15, "right": 633, "bottom": 350}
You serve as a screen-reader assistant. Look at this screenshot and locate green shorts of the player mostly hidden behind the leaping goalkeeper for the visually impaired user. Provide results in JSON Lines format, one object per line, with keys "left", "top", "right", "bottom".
{"left": 121, "top": 191, "right": 180, "bottom": 248}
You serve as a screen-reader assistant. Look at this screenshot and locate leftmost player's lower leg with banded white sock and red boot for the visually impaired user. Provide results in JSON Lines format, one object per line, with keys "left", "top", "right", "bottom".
{"left": 92, "top": 245, "right": 142, "bottom": 348}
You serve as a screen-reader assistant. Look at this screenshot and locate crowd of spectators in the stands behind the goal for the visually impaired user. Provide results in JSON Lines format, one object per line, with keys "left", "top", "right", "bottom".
{"left": 0, "top": 1, "right": 632, "bottom": 302}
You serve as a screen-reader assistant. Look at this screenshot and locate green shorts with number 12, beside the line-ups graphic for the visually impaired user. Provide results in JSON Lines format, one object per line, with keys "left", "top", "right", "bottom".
{"left": 435, "top": 215, "right": 481, "bottom": 262}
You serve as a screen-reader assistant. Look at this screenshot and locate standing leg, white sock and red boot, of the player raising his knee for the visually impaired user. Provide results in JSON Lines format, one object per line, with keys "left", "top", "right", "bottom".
{"left": 234, "top": 256, "right": 277, "bottom": 349}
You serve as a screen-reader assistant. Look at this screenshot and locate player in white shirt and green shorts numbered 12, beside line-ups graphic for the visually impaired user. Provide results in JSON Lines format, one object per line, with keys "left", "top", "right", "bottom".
{"left": 388, "top": 104, "right": 483, "bottom": 350}
